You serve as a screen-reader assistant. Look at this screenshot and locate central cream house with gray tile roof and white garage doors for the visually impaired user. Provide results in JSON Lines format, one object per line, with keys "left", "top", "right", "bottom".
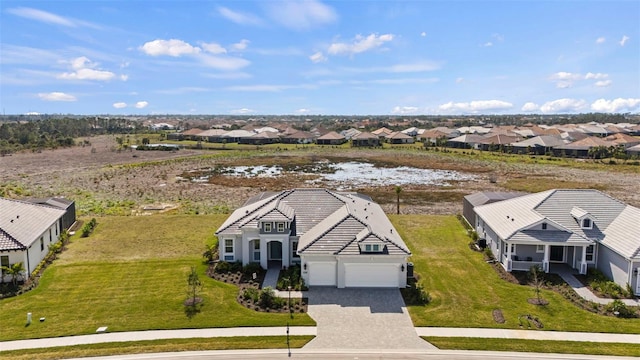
{"left": 216, "top": 189, "right": 411, "bottom": 288}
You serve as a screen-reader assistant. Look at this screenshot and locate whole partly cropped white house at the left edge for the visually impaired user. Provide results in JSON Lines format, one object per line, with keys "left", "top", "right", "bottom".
{"left": 0, "top": 198, "right": 75, "bottom": 281}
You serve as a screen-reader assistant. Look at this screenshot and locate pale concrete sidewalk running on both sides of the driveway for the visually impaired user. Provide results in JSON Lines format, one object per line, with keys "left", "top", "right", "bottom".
{"left": 5, "top": 326, "right": 640, "bottom": 351}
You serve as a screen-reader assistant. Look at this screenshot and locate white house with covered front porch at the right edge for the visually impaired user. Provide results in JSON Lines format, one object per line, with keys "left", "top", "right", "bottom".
{"left": 474, "top": 189, "right": 640, "bottom": 295}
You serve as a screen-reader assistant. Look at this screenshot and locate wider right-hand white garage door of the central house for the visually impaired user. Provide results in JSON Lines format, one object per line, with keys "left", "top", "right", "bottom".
{"left": 344, "top": 264, "right": 400, "bottom": 287}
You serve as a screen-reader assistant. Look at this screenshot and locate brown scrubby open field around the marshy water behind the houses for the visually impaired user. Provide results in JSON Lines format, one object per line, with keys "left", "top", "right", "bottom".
{"left": 0, "top": 136, "right": 640, "bottom": 215}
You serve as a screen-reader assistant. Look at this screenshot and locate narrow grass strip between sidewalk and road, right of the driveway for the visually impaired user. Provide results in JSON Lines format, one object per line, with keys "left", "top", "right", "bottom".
{"left": 424, "top": 337, "right": 640, "bottom": 356}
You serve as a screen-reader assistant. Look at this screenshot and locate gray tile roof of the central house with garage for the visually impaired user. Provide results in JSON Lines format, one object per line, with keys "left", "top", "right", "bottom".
{"left": 216, "top": 189, "right": 411, "bottom": 255}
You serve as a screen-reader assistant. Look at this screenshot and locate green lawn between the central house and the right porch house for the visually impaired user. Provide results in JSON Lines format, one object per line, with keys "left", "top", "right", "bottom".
{"left": 390, "top": 215, "right": 640, "bottom": 333}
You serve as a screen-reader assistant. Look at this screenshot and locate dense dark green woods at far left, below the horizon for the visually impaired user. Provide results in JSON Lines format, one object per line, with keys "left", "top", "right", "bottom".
{"left": 0, "top": 117, "right": 139, "bottom": 155}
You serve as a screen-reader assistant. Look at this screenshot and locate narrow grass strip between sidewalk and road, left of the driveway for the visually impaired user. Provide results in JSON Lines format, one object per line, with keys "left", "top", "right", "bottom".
{"left": 0, "top": 336, "right": 313, "bottom": 360}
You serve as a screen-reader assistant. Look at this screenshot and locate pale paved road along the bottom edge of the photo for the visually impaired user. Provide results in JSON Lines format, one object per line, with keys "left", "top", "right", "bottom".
{"left": 63, "top": 349, "right": 637, "bottom": 360}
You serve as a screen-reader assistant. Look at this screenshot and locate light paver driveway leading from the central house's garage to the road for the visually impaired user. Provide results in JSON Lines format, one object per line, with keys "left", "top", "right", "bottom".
{"left": 304, "top": 287, "right": 435, "bottom": 350}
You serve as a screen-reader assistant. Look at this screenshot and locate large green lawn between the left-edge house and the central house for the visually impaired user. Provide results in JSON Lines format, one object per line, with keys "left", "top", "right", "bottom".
{"left": 0, "top": 215, "right": 314, "bottom": 340}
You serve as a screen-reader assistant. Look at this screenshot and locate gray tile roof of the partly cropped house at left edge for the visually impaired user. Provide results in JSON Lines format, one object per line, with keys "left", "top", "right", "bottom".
{"left": 0, "top": 198, "right": 65, "bottom": 251}
